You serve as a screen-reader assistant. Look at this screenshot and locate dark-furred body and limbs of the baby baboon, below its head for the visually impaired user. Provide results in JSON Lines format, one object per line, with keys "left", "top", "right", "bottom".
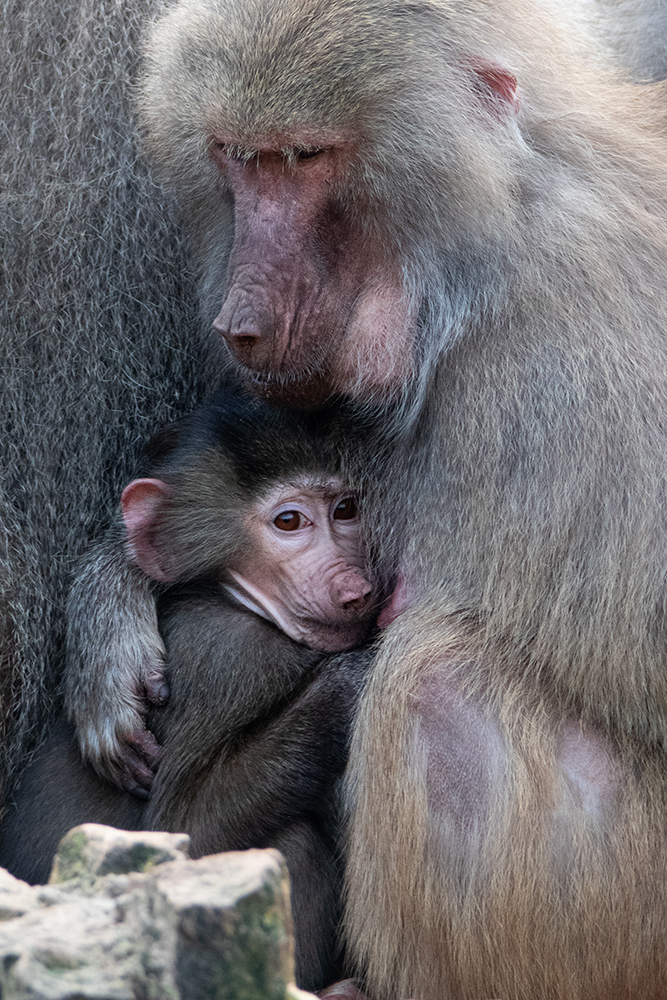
{"left": 0, "top": 616, "right": 369, "bottom": 990}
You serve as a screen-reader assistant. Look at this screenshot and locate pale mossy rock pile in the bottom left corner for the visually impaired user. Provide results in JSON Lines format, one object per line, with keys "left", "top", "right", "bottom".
{"left": 0, "top": 824, "right": 298, "bottom": 1000}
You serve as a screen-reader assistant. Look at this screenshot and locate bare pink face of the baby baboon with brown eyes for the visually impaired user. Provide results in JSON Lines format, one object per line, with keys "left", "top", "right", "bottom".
{"left": 229, "top": 478, "right": 377, "bottom": 652}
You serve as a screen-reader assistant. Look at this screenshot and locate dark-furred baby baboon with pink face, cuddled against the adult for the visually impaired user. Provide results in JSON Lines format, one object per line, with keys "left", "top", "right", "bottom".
{"left": 0, "top": 392, "right": 378, "bottom": 989}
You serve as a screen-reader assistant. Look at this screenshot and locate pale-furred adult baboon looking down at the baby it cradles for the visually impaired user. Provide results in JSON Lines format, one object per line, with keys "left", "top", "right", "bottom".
{"left": 9, "top": 0, "right": 667, "bottom": 1000}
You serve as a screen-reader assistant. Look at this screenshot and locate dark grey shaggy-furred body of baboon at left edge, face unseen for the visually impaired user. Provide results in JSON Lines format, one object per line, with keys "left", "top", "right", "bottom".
{"left": 0, "top": 0, "right": 230, "bottom": 792}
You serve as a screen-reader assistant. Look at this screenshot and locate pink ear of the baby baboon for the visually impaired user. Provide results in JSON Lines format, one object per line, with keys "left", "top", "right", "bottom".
{"left": 120, "top": 479, "right": 175, "bottom": 583}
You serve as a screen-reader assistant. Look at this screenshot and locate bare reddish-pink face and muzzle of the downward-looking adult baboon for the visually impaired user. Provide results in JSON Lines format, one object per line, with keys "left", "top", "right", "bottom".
{"left": 210, "top": 136, "right": 415, "bottom": 405}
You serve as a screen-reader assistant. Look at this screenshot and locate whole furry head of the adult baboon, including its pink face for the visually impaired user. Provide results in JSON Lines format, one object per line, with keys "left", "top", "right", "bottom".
{"left": 141, "top": 0, "right": 523, "bottom": 406}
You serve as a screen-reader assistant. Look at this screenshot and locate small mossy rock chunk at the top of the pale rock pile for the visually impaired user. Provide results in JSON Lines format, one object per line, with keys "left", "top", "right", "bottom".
{"left": 49, "top": 823, "right": 190, "bottom": 885}
